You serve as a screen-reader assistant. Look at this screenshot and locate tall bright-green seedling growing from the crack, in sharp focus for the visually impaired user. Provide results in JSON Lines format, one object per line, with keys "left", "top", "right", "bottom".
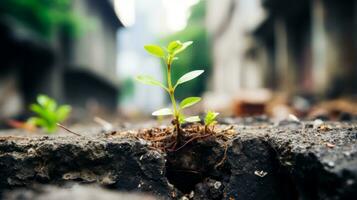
{"left": 136, "top": 40, "right": 204, "bottom": 136}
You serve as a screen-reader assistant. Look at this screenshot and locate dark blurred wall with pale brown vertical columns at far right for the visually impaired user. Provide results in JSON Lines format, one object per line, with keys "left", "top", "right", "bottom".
{"left": 254, "top": 0, "right": 357, "bottom": 98}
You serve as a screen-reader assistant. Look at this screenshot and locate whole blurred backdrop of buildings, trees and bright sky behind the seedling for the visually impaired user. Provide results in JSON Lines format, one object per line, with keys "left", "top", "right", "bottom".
{"left": 0, "top": 0, "right": 357, "bottom": 127}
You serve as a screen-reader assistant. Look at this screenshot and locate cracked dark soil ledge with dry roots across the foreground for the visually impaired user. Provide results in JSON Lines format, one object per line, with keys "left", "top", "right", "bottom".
{"left": 0, "top": 118, "right": 357, "bottom": 200}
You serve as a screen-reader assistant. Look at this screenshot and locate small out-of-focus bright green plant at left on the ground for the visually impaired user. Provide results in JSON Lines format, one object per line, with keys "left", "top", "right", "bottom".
{"left": 27, "top": 95, "right": 71, "bottom": 133}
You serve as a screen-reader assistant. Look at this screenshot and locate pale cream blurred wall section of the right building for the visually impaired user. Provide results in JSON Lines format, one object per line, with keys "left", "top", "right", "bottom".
{"left": 207, "top": 0, "right": 264, "bottom": 95}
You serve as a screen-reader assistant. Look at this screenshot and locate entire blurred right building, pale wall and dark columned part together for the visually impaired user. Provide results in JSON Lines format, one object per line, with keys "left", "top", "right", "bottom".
{"left": 207, "top": 0, "right": 357, "bottom": 97}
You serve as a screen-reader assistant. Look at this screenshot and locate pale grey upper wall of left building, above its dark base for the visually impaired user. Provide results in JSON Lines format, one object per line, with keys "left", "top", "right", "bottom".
{"left": 69, "top": 0, "right": 120, "bottom": 84}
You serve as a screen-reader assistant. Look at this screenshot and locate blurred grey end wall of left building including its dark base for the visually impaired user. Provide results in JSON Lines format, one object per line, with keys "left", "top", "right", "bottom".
{"left": 64, "top": 0, "right": 122, "bottom": 114}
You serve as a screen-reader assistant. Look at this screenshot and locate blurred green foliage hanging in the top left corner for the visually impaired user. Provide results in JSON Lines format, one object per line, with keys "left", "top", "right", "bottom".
{"left": 0, "top": 0, "right": 80, "bottom": 37}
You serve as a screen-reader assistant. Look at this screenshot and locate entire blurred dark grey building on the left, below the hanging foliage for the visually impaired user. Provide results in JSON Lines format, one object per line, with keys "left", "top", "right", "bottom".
{"left": 0, "top": 0, "right": 122, "bottom": 122}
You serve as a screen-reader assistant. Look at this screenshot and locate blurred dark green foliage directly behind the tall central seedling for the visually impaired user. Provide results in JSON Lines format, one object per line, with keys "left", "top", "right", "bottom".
{"left": 160, "top": 0, "right": 212, "bottom": 99}
